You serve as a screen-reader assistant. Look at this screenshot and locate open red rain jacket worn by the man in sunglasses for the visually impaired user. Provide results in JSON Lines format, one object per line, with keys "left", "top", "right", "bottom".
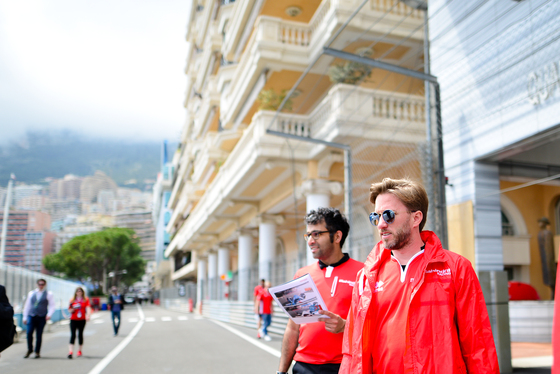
{"left": 339, "top": 231, "right": 499, "bottom": 374}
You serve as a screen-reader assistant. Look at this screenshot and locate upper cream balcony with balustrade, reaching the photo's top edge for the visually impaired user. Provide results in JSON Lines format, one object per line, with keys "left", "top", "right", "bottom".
{"left": 220, "top": 0, "right": 423, "bottom": 128}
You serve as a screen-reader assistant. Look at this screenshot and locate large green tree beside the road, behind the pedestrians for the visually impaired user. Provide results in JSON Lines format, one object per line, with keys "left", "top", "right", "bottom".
{"left": 43, "top": 228, "right": 146, "bottom": 286}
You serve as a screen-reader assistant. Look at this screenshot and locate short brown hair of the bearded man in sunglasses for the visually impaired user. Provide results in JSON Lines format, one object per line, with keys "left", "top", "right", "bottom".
{"left": 369, "top": 178, "right": 430, "bottom": 231}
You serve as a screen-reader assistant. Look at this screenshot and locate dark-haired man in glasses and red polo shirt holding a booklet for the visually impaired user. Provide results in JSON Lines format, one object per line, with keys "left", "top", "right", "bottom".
{"left": 277, "top": 208, "right": 363, "bottom": 374}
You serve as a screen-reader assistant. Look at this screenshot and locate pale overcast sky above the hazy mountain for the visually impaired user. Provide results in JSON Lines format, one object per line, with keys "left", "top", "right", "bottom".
{"left": 0, "top": 0, "right": 190, "bottom": 143}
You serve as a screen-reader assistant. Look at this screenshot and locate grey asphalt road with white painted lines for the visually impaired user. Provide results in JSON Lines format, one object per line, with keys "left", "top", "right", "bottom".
{"left": 0, "top": 305, "right": 281, "bottom": 374}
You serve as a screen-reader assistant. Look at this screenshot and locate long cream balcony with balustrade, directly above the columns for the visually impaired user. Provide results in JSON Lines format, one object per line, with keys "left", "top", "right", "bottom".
{"left": 166, "top": 84, "right": 425, "bottom": 256}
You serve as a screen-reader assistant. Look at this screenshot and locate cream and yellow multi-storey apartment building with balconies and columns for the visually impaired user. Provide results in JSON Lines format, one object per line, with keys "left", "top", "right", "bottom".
{"left": 165, "top": 0, "right": 431, "bottom": 301}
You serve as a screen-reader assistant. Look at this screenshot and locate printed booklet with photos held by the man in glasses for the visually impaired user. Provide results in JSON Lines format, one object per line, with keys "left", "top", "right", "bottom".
{"left": 268, "top": 274, "right": 329, "bottom": 325}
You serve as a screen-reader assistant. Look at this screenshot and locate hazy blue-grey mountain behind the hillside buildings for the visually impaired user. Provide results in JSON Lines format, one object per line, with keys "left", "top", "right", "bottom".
{"left": 0, "top": 131, "right": 165, "bottom": 188}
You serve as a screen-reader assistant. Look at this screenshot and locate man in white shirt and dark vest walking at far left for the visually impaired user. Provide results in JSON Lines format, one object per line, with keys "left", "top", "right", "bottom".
{"left": 23, "top": 278, "right": 55, "bottom": 358}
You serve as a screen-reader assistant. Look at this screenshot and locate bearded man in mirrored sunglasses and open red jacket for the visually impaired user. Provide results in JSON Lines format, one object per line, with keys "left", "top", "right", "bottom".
{"left": 340, "top": 178, "right": 499, "bottom": 374}
